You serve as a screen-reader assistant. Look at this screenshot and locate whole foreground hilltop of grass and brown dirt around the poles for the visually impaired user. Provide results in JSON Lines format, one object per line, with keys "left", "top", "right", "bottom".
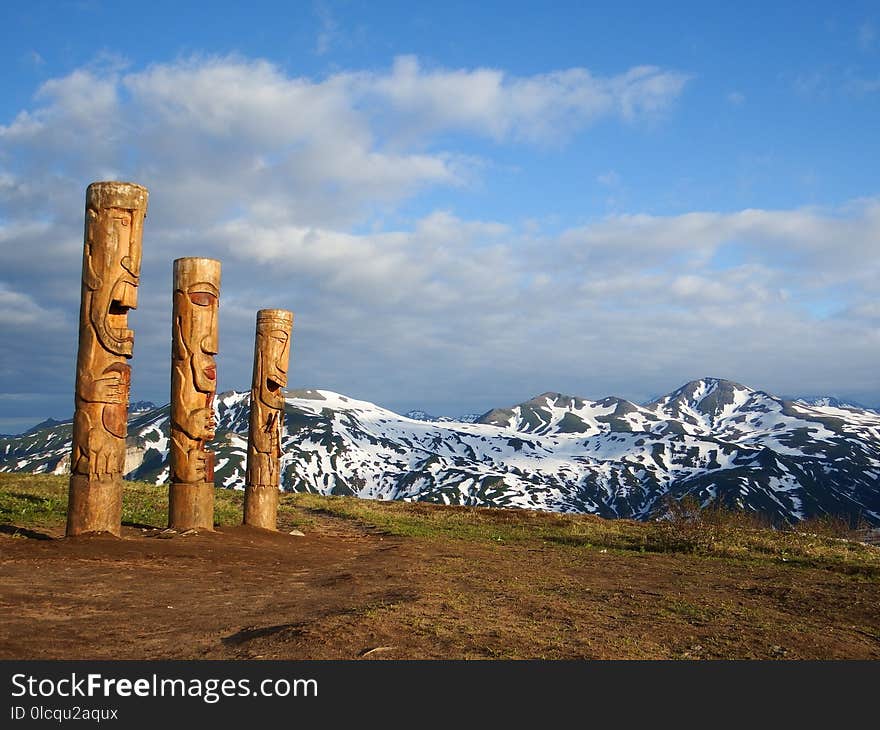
{"left": 0, "top": 474, "right": 880, "bottom": 659}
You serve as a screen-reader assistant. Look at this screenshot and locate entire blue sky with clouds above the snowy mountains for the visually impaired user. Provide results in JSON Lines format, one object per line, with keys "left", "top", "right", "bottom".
{"left": 0, "top": 0, "right": 880, "bottom": 432}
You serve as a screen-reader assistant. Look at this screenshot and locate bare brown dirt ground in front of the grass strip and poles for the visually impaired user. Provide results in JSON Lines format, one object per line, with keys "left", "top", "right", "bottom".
{"left": 0, "top": 506, "right": 880, "bottom": 659}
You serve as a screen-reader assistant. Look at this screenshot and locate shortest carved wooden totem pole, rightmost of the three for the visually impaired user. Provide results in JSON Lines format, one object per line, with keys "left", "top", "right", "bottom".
{"left": 244, "top": 309, "right": 293, "bottom": 530}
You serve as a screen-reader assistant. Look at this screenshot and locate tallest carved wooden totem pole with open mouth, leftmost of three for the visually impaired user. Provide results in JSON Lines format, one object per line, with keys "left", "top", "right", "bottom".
{"left": 67, "top": 182, "right": 148, "bottom": 536}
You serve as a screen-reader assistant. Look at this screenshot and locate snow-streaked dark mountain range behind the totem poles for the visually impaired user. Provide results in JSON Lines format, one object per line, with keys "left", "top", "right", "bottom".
{"left": 0, "top": 378, "right": 880, "bottom": 524}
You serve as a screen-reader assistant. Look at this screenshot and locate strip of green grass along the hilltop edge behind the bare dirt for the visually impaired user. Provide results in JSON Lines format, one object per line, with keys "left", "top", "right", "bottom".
{"left": 0, "top": 473, "right": 880, "bottom": 580}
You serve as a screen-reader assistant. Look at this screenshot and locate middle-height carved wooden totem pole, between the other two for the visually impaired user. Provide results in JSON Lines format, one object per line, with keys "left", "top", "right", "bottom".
{"left": 168, "top": 258, "right": 220, "bottom": 530}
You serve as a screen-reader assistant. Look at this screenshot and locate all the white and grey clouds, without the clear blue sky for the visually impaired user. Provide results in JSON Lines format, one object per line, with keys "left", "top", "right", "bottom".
{"left": 0, "top": 58, "right": 880, "bottom": 415}
